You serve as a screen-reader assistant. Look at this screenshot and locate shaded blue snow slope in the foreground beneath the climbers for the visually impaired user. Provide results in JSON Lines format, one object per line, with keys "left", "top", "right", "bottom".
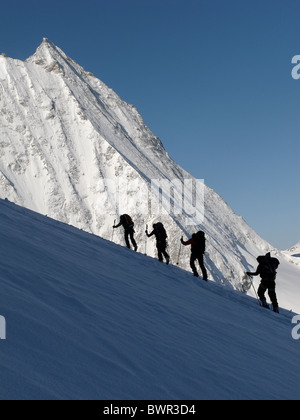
{"left": 0, "top": 200, "right": 300, "bottom": 400}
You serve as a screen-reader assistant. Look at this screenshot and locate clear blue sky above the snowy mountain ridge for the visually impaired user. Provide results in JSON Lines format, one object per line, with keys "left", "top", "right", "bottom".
{"left": 0, "top": 0, "right": 300, "bottom": 249}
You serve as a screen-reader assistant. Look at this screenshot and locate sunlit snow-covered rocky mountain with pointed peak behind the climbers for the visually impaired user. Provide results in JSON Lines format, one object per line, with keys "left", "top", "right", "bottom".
{"left": 0, "top": 39, "right": 299, "bottom": 294}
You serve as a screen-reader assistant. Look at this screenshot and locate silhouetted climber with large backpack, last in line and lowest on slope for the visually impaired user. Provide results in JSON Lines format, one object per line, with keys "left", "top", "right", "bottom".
{"left": 247, "top": 252, "right": 280, "bottom": 313}
